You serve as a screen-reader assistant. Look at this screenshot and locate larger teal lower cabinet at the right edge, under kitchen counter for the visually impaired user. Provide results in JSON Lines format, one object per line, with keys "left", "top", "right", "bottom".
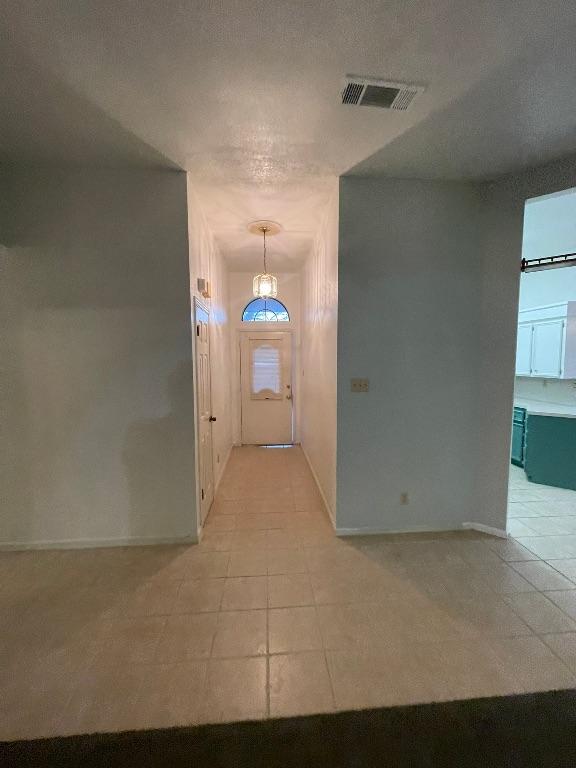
{"left": 524, "top": 413, "right": 576, "bottom": 490}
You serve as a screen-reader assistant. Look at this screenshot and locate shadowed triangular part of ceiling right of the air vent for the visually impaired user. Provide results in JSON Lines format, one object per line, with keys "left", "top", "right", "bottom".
{"left": 350, "top": 21, "right": 576, "bottom": 179}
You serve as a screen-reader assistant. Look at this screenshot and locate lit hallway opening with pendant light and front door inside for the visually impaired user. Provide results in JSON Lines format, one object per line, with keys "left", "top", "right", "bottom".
{"left": 189, "top": 185, "right": 339, "bottom": 540}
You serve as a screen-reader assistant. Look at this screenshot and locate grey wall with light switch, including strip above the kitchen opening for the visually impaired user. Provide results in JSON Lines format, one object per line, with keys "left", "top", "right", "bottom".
{"left": 337, "top": 156, "right": 576, "bottom": 532}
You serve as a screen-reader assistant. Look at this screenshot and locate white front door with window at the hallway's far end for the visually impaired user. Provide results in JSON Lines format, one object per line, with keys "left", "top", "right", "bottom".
{"left": 240, "top": 332, "right": 293, "bottom": 445}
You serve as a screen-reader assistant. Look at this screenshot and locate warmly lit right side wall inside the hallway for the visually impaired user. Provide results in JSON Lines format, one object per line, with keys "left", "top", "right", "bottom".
{"left": 300, "top": 181, "right": 338, "bottom": 522}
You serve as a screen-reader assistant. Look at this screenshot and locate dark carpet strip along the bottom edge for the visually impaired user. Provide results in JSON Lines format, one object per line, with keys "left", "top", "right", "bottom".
{"left": 0, "top": 691, "right": 576, "bottom": 768}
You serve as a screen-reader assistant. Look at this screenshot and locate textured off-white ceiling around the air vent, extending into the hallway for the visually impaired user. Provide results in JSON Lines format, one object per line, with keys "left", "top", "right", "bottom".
{"left": 0, "top": 0, "right": 576, "bottom": 268}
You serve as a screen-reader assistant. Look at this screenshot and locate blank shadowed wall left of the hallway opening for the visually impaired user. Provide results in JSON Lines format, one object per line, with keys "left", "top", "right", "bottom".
{"left": 0, "top": 169, "right": 196, "bottom": 546}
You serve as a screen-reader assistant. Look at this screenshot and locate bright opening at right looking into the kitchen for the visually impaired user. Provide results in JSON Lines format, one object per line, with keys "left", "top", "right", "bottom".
{"left": 507, "top": 189, "right": 576, "bottom": 552}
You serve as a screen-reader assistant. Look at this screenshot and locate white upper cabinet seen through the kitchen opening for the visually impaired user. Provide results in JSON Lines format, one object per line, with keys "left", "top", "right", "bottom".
{"left": 516, "top": 301, "right": 576, "bottom": 379}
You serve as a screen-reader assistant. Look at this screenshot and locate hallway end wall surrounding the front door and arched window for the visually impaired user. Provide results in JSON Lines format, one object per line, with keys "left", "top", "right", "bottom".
{"left": 228, "top": 272, "right": 301, "bottom": 445}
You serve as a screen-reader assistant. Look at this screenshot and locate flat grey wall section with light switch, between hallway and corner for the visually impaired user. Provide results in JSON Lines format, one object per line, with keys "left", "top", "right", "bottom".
{"left": 337, "top": 177, "right": 485, "bottom": 532}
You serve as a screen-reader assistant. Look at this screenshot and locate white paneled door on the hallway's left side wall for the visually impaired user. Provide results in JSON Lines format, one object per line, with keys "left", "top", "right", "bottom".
{"left": 195, "top": 304, "right": 216, "bottom": 525}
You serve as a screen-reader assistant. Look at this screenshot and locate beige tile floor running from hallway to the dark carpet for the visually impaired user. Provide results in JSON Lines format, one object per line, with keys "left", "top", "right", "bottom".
{"left": 0, "top": 448, "right": 576, "bottom": 739}
